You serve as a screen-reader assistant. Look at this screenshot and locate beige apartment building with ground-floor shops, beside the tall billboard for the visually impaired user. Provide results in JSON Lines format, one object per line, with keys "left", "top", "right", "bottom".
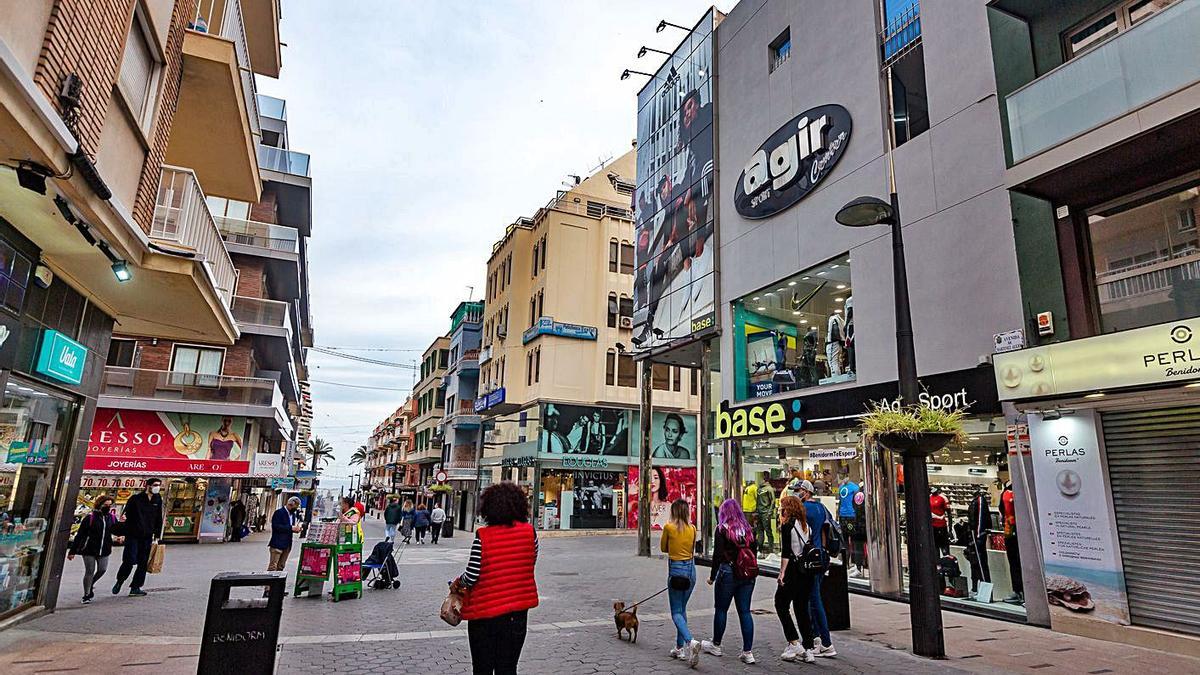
{"left": 475, "top": 151, "right": 700, "bottom": 530}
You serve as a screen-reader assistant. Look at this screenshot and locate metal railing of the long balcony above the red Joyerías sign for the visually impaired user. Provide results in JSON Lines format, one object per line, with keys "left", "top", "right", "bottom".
{"left": 100, "top": 366, "right": 283, "bottom": 406}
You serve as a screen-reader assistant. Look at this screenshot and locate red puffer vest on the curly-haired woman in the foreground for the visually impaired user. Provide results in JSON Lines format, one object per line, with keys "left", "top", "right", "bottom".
{"left": 462, "top": 522, "right": 538, "bottom": 621}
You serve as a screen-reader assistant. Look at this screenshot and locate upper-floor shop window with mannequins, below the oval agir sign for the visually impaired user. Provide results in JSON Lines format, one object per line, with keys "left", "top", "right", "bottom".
{"left": 733, "top": 255, "right": 856, "bottom": 400}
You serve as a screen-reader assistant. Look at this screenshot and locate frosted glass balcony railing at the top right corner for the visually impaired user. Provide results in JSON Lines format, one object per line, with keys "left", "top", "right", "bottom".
{"left": 1006, "top": 0, "right": 1200, "bottom": 162}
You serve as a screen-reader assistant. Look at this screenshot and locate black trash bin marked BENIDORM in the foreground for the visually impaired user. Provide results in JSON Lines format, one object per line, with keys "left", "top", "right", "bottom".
{"left": 196, "top": 572, "right": 287, "bottom": 675}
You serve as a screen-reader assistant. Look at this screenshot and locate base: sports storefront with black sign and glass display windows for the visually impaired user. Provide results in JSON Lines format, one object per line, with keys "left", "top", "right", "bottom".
{"left": 702, "top": 368, "right": 1025, "bottom": 619}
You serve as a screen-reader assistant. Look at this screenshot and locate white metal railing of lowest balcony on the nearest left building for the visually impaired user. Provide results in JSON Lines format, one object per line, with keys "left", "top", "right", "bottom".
{"left": 150, "top": 165, "right": 238, "bottom": 305}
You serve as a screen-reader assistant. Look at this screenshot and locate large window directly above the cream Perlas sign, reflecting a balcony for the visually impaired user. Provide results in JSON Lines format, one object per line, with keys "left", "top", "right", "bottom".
{"left": 1087, "top": 185, "right": 1200, "bottom": 333}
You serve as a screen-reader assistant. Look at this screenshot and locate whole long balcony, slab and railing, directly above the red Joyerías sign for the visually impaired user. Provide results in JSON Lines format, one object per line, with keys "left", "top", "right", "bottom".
{"left": 98, "top": 366, "right": 290, "bottom": 422}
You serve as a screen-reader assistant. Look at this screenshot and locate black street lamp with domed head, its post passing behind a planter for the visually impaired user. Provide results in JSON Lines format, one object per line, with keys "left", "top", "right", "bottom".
{"left": 834, "top": 189, "right": 946, "bottom": 658}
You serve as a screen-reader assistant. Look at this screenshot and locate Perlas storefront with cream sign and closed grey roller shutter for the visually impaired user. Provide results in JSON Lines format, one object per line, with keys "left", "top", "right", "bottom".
{"left": 996, "top": 314, "right": 1200, "bottom": 653}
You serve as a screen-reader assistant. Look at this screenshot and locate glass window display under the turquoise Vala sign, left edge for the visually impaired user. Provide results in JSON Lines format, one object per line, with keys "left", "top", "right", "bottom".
{"left": 0, "top": 376, "right": 78, "bottom": 616}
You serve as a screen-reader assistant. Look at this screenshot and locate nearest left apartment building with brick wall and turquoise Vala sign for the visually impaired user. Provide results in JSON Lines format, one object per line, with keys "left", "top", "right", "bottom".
{"left": 0, "top": 0, "right": 288, "bottom": 619}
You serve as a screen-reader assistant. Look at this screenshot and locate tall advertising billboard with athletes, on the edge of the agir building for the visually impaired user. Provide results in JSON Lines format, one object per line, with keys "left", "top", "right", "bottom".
{"left": 634, "top": 10, "right": 716, "bottom": 346}
